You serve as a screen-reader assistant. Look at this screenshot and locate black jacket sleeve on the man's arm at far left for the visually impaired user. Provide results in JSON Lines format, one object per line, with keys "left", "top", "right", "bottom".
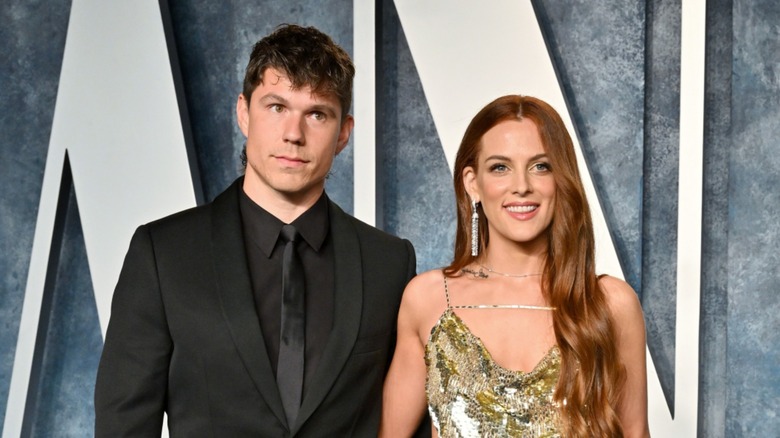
{"left": 95, "top": 226, "right": 172, "bottom": 437}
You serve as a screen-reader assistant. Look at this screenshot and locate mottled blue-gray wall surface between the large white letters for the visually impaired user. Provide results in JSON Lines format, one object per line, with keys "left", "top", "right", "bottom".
{"left": 0, "top": 0, "right": 780, "bottom": 437}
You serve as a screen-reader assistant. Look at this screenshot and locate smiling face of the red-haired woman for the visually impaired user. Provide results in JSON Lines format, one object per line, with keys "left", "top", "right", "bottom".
{"left": 463, "top": 118, "right": 556, "bottom": 252}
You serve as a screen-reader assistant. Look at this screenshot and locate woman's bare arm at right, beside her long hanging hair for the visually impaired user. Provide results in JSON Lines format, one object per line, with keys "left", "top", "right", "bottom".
{"left": 599, "top": 276, "right": 650, "bottom": 438}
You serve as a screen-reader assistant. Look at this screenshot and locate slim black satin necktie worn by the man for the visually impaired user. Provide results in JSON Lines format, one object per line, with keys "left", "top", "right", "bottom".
{"left": 276, "top": 225, "right": 306, "bottom": 428}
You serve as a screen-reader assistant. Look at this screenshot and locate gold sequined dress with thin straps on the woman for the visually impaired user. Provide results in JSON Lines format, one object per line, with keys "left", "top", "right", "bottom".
{"left": 425, "top": 277, "right": 561, "bottom": 438}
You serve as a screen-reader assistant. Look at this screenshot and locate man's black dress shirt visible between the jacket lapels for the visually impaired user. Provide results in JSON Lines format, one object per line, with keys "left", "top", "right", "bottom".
{"left": 239, "top": 190, "right": 335, "bottom": 394}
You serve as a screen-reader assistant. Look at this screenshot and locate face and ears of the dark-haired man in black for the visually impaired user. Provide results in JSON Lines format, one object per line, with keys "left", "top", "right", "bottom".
{"left": 236, "top": 68, "right": 354, "bottom": 207}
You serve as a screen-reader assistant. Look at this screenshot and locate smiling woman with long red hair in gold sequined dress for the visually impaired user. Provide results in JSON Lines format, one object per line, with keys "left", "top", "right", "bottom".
{"left": 380, "top": 96, "right": 649, "bottom": 437}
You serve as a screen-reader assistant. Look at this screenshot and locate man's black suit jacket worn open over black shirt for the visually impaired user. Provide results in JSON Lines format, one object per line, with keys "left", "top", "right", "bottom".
{"left": 95, "top": 179, "right": 415, "bottom": 437}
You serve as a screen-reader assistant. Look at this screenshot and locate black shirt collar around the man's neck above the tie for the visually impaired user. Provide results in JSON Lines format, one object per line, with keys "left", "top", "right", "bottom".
{"left": 239, "top": 190, "right": 330, "bottom": 257}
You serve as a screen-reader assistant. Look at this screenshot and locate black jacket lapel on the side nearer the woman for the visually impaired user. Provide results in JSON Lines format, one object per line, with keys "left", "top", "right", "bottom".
{"left": 292, "top": 202, "right": 363, "bottom": 434}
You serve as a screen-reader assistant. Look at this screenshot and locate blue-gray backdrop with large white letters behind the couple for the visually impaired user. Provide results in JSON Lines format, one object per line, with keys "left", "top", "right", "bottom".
{"left": 0, "top": 0, "right": 780, "bottom": 437}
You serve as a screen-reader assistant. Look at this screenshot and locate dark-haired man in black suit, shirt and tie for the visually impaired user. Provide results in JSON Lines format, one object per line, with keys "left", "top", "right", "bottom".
{"left": 95, "top": 25, "right": 415, "bottom": 437}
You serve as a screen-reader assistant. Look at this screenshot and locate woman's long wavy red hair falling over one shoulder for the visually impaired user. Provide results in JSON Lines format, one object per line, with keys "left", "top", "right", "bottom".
{"left": 444, "top": 95, "right": 625, "bottom": 437}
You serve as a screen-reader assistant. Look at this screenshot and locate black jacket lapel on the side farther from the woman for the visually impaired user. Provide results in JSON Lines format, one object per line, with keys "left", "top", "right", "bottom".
{"left": 211, "top": 178, "right": 287, "bottom": 424}
